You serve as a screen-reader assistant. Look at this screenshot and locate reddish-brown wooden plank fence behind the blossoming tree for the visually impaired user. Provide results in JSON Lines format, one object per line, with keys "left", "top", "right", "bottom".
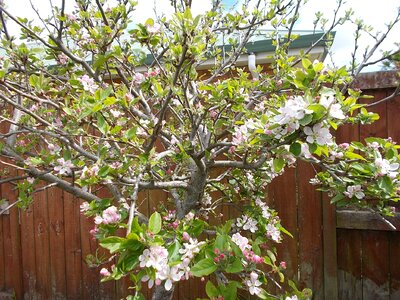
{"left": 0, "top": 73, "right": 400, "bottom": 300}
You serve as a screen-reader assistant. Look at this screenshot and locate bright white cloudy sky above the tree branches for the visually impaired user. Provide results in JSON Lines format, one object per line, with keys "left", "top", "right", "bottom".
{"left": 4, "top": 0, "right": 400, "bottom": 70}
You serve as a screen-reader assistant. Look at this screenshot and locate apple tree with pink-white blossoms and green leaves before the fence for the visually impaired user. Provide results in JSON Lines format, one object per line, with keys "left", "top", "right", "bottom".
{"left": 0, "top": 0, "right": 400, "bottom": 299}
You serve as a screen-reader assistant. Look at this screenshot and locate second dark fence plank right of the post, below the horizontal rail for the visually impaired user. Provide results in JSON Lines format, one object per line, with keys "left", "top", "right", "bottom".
{"left": 362, "top": 230, "right": 389, "bottom": 300}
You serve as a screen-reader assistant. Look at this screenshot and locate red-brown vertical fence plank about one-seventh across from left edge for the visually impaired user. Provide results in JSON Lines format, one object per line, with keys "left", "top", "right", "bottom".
{"left": 47, "top": 188, "right": 66, "bottom": 299}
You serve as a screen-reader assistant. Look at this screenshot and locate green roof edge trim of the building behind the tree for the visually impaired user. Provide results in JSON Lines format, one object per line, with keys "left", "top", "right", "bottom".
{"left": 144, "top": 32, "right": 335, "bottom": 65}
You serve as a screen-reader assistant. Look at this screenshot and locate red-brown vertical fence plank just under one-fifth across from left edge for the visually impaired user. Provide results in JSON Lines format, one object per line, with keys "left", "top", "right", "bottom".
{"left": 63, "top": 192, "right": 82, "bottom": 300}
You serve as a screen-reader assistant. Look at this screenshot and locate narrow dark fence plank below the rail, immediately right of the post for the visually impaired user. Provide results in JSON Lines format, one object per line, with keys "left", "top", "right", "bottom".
{"left": 337, "top": 229, "right": 362, "bottom": 300}
